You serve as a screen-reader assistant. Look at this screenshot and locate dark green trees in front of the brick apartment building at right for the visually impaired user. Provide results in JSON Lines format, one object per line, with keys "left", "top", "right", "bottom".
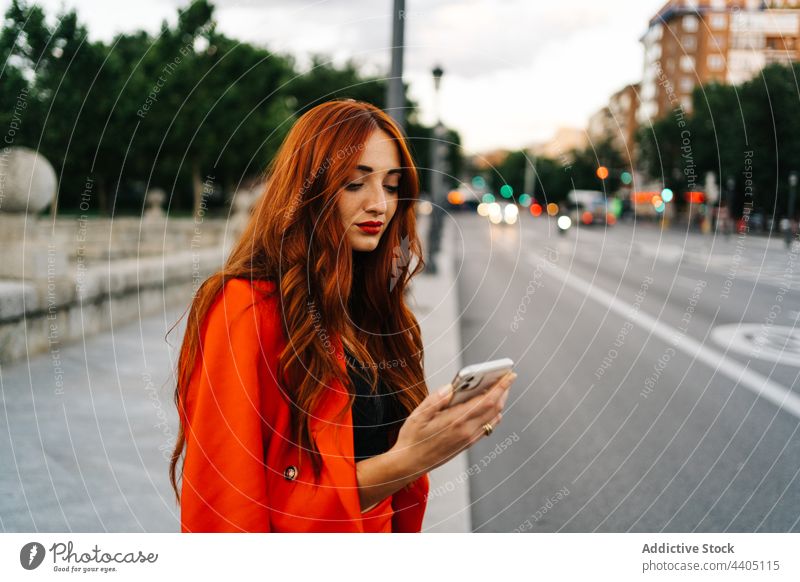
{"left": 638, "top": 63, "right": 800, "bottom": 216}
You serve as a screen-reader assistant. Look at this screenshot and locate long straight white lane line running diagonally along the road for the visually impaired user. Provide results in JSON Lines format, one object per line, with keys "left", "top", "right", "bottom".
{"left": 529, "top": 255, "right": 800, "bottom": 419}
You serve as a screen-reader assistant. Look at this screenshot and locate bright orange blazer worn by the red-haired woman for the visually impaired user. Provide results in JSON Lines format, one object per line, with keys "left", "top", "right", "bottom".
{"left": 181, "top": 279, "right": 430, "bottom": 532}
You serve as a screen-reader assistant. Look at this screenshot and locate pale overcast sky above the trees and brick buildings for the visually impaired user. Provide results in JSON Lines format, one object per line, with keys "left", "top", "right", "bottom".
{"left": 0, "top": 0, "right": 664, "bottom": 155}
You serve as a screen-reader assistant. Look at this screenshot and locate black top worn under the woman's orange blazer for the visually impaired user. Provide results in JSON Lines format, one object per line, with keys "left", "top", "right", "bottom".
{"left": 344, "top": 348, "right": 400, "bottom": 461}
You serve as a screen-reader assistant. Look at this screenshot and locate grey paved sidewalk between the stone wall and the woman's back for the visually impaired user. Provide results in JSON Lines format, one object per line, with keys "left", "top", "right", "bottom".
{"left": 0, "top": 309, "right": 183, "bottom": 532}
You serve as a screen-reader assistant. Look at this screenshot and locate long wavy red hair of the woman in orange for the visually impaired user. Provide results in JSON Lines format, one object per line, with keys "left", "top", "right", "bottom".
{"left": 169, "top": 99, "right": 428, "bottom": 500}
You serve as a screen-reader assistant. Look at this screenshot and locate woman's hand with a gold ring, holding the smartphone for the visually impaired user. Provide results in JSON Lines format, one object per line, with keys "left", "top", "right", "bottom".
{"left": 392, "top": 372, "right": 517, "bottom": 476}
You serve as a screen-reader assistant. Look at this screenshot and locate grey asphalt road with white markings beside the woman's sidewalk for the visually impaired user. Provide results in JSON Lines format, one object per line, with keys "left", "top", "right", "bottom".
{"left": 450, "top": 214, "right": 800, "bottom": 532}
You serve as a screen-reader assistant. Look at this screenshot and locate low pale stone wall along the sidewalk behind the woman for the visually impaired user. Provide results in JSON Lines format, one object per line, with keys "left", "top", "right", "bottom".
{"left": 0, "top": 215, "right": 233, "bottom": 363}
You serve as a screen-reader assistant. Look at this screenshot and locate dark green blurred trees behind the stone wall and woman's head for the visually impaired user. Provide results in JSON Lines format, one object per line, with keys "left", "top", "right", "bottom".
{"left": 0, "top": 0, "right": 459, "bottom": 214}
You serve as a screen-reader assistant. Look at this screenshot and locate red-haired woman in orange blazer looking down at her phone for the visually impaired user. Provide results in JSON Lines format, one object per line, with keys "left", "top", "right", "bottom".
{"left": 170, "top": 99, "right": 512, "bottom": 532}
